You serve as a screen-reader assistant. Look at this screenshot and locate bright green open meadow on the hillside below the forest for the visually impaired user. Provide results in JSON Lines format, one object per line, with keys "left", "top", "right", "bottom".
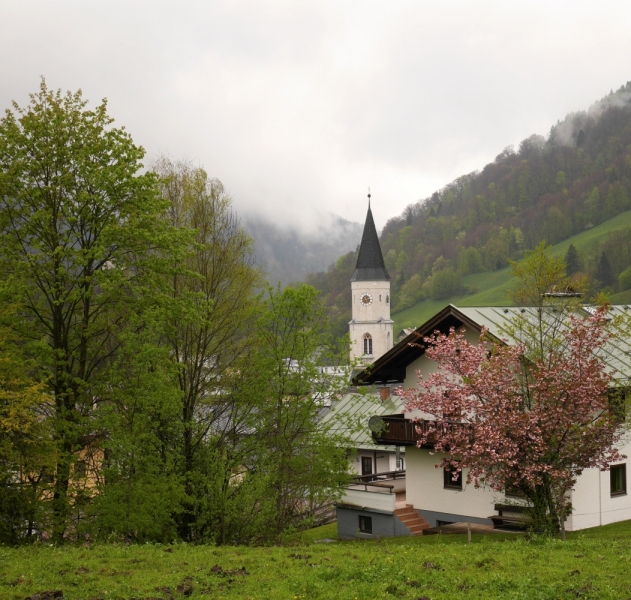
{"left": 392, "top": 210, "right": 631, "bottom": 333}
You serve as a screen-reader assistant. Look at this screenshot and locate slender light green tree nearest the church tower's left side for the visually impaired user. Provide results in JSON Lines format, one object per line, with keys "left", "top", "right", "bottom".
{"left": 257, "top": 286, "right": 350, "bottom": 533}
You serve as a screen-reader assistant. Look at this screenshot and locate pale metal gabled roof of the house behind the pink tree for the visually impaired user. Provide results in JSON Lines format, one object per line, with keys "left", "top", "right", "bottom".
{"left": 353, "top": 304, "right": 631, "bottom": 385}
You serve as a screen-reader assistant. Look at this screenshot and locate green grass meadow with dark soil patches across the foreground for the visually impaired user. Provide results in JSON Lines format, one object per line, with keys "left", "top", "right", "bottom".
{"left": 0, "top": 522, "right": 631, "bottom": 600}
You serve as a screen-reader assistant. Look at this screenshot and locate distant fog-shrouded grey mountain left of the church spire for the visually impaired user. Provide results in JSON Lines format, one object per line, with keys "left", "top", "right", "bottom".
{"left": 241, "top": 212, "right": 363, "bottom": 285}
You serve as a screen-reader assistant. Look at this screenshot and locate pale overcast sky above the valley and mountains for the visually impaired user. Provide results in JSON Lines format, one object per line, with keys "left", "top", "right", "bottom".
{"left": 0, "top": 0, "right": 631, "bottom": 228}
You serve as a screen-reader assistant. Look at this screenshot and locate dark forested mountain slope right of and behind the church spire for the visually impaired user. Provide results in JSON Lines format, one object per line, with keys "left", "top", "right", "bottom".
{"left": 307, "top": 82, "right": 631, "bottom": 340}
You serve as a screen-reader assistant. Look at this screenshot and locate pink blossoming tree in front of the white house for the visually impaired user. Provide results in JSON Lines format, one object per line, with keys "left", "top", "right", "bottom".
{"left": 404, "top": 307, "right": 623, "bottom": 533}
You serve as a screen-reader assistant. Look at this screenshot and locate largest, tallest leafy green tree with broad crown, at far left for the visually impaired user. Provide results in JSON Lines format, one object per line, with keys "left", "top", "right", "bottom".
{"left": 0, "top": 81, "right": 185, "bottom": 543}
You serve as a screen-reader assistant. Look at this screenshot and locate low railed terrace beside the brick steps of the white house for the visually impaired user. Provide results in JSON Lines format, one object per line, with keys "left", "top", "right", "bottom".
{"left": 338, "top": 471, "right": 405, "bottom": 513}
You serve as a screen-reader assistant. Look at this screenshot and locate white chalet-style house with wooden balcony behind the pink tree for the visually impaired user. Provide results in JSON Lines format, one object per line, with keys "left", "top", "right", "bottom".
{"left": 338, "top": 305, "right": 631, "bottom": 537}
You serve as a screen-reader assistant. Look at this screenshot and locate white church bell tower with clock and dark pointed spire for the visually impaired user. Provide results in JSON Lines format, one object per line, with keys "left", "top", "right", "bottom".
{"left": 348, "top": 194, "right": 394, "bottom": 365}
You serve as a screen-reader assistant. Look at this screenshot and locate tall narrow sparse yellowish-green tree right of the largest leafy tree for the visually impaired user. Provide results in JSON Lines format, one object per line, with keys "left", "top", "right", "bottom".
{"left": 153, "top": 157, "right": 259, "bottom": 539}
